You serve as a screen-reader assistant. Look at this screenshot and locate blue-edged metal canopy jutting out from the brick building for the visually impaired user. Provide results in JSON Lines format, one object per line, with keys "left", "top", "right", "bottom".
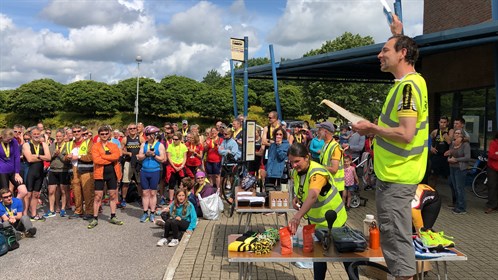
{"left": 235, "top": 21, "right": 498, "bottom": 83}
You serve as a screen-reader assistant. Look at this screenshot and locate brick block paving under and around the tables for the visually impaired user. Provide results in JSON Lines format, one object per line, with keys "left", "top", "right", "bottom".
{"left": 164, "top": 183, "right": 498, "bottom": 280}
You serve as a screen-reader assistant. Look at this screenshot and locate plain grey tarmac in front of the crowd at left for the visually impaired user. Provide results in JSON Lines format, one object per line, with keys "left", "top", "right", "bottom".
{"left": 0, "top": 202, "right": 175, "bottom": 280}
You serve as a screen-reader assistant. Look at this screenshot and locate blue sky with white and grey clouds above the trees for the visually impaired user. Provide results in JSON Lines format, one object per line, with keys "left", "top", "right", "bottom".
{"left": 0, "top": 0, "right": 423, "bottom": 89}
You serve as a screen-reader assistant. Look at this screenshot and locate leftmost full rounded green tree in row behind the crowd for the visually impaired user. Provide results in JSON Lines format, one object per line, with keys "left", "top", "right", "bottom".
{"left": 9, "top": 79, "right": 64, "bottom": 120}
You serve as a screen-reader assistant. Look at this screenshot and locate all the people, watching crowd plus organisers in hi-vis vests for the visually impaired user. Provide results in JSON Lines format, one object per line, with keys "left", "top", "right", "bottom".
{"left": 0, "top": 16, "right": 498, "bottom": 279}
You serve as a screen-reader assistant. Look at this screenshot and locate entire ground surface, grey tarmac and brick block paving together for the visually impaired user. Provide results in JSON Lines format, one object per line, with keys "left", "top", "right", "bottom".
{"left": 4, "top": 183, "right": 498, "bottom": 280}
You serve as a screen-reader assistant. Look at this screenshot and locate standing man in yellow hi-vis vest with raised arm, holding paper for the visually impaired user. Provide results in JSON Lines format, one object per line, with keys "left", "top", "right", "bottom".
{"left": 353, "top": 15, "right": 429, "bottom": 279}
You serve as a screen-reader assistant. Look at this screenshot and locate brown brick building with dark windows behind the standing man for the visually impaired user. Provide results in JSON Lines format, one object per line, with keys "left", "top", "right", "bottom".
{"left": 419, "top": 0, "right": 498, "bottom": 150}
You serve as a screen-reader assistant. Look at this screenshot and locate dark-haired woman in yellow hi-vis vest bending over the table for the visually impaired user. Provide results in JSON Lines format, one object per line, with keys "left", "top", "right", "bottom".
{"left": 288, "top": 143, "right": 347, "bottom": 279}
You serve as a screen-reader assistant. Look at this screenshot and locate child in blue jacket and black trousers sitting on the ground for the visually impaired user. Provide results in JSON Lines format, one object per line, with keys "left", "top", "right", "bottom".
{"left": 157, "top": 188, "right": 197, "bottom": 247}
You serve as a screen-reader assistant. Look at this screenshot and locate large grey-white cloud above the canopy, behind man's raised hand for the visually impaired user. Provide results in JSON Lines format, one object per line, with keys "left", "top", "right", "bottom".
{"left": 266, "top": 0, "right": 423, "bottom": 58}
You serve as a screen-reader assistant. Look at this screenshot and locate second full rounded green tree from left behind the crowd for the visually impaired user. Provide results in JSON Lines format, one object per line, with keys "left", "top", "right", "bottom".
{"left": 62, "top": 80, "right": 122, "bottom": 115}
